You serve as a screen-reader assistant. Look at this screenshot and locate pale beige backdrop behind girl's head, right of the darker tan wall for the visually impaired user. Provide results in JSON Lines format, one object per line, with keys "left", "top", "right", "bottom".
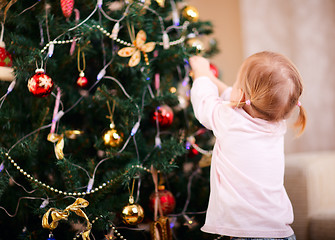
{"left": 240, "top": 0, "right": 335, "bottom": 152}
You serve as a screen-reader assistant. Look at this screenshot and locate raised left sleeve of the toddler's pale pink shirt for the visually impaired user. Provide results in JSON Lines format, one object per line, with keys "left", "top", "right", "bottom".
{"left": 191, "top": 77, "right": 226, "bottom": 130}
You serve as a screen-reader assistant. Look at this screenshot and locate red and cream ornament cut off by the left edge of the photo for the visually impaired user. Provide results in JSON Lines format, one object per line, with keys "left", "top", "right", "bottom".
{"left": 0, "top": 41, "right": 14, "bottom": 81}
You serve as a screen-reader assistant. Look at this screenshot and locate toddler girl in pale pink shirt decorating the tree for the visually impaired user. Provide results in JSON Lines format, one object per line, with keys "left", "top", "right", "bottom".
{"left": 190, "top": 52, "right": 306, "bottom": 240}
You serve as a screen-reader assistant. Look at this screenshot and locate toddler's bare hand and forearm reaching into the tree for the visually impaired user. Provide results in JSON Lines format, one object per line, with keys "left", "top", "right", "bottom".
{"left": 190, "top": 56, "right": 228, "bottom": 95}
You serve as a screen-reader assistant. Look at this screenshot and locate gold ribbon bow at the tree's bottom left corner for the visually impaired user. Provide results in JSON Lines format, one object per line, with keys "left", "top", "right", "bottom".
{"left": 42, "top": 198, "right": 92, "bottom": 240}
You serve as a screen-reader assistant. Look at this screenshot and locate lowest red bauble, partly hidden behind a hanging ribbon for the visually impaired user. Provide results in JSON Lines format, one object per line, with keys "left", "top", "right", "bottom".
{"left": 149, "top": 185, "right": 176, "bottom": 215}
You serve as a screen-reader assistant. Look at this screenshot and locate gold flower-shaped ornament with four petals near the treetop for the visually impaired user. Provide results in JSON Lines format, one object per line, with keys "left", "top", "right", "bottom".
{"left": 118, "top": 30, "right": 156, "bottom": 67}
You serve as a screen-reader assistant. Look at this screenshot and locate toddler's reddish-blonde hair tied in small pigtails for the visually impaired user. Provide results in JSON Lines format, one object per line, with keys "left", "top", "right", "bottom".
{"left": 237, "top": 51, "right": 306, "bottom": 134}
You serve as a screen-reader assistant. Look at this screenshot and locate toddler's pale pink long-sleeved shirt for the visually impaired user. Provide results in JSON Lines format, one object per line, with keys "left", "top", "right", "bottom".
{"left": 191, "top": 77, "right": 293, "bottom": 238}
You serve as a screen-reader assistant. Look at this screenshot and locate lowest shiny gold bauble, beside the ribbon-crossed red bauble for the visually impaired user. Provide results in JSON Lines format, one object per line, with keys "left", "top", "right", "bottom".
{"left": 121, "top": 197, "right": 144, "bottom": 225}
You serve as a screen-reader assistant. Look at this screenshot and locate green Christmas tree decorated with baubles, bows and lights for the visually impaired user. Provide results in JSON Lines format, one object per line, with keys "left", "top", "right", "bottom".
{"left": 0, "top": 0, "right": 217, "bottom": 240}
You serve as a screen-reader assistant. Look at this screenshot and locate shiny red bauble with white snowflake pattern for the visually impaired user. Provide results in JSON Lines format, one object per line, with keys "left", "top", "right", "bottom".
{"left": 28, "top": 68, "right": 54, "bottom": 97}
